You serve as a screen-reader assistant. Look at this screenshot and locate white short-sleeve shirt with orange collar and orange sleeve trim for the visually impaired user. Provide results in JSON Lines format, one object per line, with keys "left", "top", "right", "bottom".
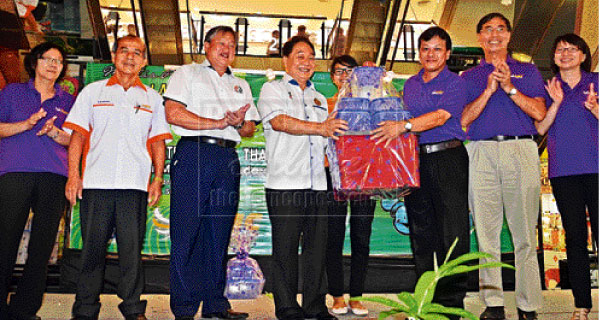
{"left": 63, "top": 76, "right": 172, "bottom": 191}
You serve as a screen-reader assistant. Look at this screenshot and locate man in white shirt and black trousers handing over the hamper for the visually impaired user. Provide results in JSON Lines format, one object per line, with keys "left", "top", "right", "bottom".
{"left": 258, "top": 36, "right": 348, "bottom": 320}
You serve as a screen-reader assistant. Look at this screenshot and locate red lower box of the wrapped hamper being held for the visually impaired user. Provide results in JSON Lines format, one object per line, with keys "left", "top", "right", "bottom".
{"left": 332, "top": 134, "right": 420, "bottom": 198}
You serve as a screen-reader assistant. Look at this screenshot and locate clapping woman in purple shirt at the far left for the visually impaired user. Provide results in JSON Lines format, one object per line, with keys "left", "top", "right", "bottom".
{"left": 0, "top": 43, "right": 74, "bottom": 320}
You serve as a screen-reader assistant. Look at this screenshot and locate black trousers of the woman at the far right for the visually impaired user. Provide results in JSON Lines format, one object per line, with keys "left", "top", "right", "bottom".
{"left": 550, "top": 174, "right": 598, "bottom": 308}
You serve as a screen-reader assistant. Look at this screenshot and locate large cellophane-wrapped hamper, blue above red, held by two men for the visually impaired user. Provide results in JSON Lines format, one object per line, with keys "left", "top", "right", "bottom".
{"left": 327, "top": 67, "right": 420, "bottom": 200}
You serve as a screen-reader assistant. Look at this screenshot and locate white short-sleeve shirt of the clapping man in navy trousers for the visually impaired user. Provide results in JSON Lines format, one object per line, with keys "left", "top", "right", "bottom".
{"left": 164, "top": 60, "right": 259, "bottom": 142}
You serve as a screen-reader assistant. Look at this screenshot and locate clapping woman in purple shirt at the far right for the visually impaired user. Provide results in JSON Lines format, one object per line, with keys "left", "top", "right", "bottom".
{"left": 536, "top": 33, "right": 598, "bottom": 320}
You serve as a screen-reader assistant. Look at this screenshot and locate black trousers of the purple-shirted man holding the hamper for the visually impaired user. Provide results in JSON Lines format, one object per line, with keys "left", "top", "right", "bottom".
{"left": 404, "top": 145, "right": 469, "bottom": 308}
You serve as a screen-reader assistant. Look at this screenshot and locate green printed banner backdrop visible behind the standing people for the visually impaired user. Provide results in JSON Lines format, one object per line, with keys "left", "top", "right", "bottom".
{"left": 69, "top": 63, "right": 513, "bottom": 255}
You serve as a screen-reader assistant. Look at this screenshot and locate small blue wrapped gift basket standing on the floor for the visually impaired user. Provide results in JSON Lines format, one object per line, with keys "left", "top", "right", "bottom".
{"left": 225, "top": 223, "right": 265, "bottom": 300}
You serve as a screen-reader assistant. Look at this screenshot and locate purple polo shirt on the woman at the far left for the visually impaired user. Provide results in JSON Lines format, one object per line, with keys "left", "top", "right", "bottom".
{"left": 0, "top": 80, "right": 75, "bottom": 176}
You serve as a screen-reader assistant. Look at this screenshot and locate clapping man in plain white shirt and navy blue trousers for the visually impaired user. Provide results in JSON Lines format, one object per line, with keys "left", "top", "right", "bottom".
{"left": 164, "top": 26, "right": 258, "bottom": 320}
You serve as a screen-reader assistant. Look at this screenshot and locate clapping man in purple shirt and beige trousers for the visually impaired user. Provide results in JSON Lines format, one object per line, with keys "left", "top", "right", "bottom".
{"left": 461, "top": 13, "right": 546, "bottom": 320}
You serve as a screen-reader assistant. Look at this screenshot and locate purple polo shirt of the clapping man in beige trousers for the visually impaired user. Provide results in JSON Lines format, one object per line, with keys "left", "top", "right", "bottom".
{"left": 461, "top": 57, "right": 547, "bottom": 140}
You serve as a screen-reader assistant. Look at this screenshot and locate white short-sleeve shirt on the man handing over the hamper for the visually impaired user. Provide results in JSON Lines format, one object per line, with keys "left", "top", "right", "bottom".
{"left": 258, "top": 74, "right": 327, "bottom": 190}
